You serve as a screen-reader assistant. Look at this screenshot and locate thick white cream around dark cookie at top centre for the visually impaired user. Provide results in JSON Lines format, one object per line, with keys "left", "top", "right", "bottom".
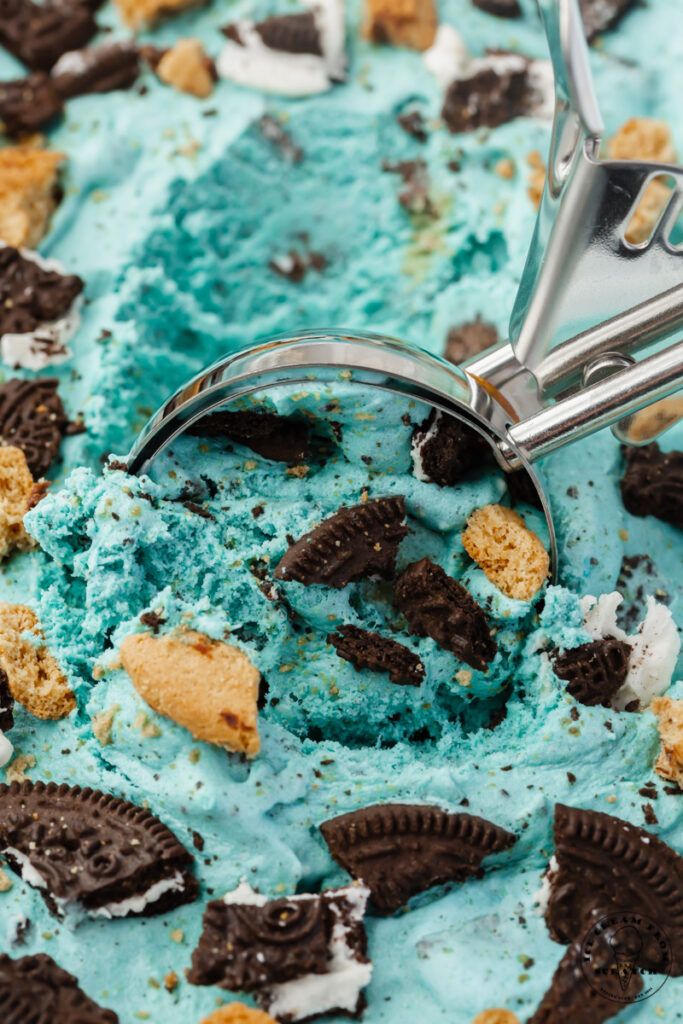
{"left": 216, "top": 0, "right": 346, "bottom": 96}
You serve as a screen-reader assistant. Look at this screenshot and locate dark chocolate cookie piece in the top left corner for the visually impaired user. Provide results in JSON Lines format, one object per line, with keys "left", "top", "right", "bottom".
{"left": 0, "top": 0, "right": 97, "bottom": 71}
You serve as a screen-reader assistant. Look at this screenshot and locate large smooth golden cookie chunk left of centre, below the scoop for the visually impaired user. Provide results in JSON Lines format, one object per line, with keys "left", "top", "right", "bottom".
{"left": 121, "top": 631, "right": 261, "bottom": 757}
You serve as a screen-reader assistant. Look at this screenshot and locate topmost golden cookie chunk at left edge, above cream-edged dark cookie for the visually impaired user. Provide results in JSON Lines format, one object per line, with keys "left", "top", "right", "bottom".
{"left": 0, "top": 145, "right": 65, "bottom": 249}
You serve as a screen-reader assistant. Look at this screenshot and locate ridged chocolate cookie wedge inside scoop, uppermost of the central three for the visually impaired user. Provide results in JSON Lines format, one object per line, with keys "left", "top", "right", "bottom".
{"left": 273, "top": 496, "right": 408, "bottom": 588}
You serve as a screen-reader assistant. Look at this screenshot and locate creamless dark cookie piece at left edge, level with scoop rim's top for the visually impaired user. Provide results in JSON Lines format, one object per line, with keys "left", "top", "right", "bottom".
{"left": 0, "top": 377, "right": 73, "bottom": 477}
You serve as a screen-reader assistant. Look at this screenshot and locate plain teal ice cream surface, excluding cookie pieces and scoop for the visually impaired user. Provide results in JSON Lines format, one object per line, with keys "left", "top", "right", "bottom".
{"left": 0, "top": 0, "right": 683, "bottom": 1024}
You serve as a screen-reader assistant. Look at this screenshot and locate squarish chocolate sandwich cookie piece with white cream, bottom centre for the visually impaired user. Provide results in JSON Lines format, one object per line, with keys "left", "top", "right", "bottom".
{"left": 187, "top": 882, "right": 373, "bottom": 1021}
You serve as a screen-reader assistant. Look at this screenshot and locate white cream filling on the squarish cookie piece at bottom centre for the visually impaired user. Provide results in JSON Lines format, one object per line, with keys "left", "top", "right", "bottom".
{"left": 223, "top": 879, "right": 373, "bottom": 1021}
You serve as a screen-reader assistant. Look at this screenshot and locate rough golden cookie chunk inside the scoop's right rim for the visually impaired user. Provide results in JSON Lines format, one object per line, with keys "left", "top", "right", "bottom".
{"left": 462, "top": 505, "right": 550, "bottom": 601}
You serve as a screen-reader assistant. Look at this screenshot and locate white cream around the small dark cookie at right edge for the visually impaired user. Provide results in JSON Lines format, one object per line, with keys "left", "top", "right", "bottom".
{"left": 581, "top": 591, "right": 681, "bottom": 711}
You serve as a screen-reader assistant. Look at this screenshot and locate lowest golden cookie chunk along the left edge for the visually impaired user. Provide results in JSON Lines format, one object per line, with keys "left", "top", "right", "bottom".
{"left": 0, "top": 601, "right": 76, "bottom": 719}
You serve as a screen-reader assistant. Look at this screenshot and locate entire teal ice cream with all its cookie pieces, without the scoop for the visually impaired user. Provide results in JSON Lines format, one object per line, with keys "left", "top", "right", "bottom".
{"left": 0, "top": 0, "right": 683, "bottom": 1024}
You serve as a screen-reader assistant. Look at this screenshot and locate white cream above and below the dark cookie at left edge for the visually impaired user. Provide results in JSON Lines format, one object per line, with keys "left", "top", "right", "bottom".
{"left": 0, "top": 243, "right": 83, "bottom": 370}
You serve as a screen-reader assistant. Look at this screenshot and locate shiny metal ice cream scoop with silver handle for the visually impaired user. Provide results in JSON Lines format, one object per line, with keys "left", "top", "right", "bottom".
{"left": 128, "top": 0, "right": 683, "bottom": 577}
